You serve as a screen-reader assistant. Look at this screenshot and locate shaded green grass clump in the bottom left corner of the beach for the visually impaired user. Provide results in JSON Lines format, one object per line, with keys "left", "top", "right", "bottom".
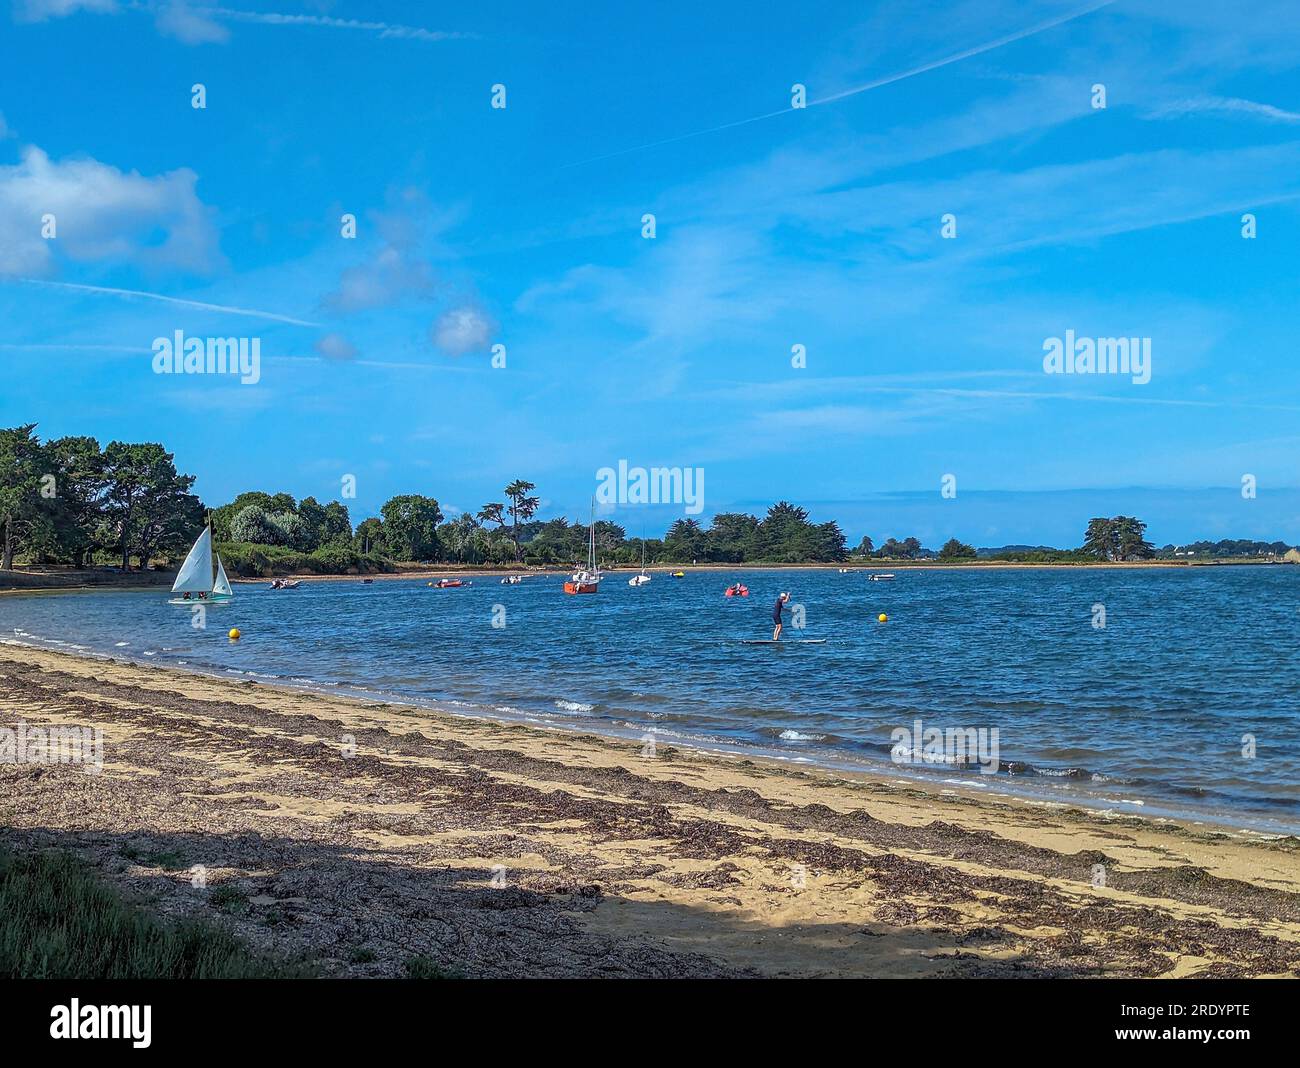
{"left": 0, "top": 848, "right": 309, "bottom": 980}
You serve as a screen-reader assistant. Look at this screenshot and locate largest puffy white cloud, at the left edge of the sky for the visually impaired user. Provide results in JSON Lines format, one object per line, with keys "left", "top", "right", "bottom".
{"left": 0, "top": 146, "right": 221, "bottom": 275}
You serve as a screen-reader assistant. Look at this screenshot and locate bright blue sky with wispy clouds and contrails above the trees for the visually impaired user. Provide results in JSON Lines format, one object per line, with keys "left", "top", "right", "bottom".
{"left": 0, "top": 0, "right": 1300, "bottom": 544}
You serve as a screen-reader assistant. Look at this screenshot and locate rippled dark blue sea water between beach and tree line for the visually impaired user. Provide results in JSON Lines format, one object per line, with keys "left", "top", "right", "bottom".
{"left": 0, "top": 565, "right": 1300, "bottom": 833}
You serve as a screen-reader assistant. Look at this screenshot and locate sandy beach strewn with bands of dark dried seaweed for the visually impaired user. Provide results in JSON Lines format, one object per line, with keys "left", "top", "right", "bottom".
{"left": 0, "top": 646, "right": 1300, "bottom": 977}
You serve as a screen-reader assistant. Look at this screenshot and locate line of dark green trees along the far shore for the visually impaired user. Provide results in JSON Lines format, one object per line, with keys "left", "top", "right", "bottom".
{"left": 0, "top": 424, "right": 1268, "bottom": 574}
